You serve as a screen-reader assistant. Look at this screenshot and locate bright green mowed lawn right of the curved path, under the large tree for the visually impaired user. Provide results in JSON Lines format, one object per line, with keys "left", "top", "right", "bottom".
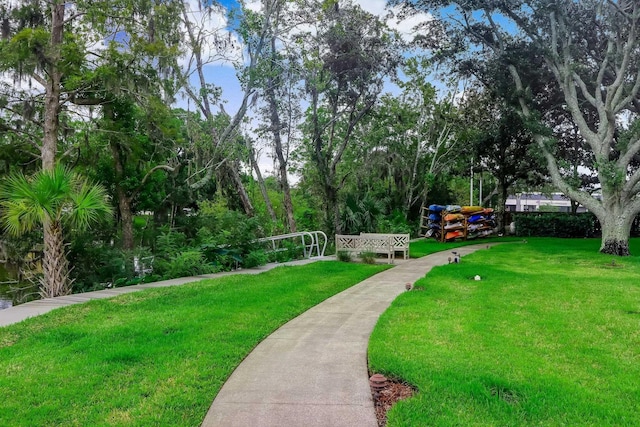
{"left": 369, "top": 239, "right": 640, "bottom": 426}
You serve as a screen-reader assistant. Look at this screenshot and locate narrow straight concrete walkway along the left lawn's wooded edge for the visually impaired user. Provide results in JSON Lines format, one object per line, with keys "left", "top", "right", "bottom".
{"left": 0, "top": 257, "right": 335, "bottom": 327}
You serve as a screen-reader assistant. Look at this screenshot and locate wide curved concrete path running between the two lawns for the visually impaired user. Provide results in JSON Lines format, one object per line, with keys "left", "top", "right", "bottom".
{"left": 202, "top": 243, "right": 491, "bottom": 427}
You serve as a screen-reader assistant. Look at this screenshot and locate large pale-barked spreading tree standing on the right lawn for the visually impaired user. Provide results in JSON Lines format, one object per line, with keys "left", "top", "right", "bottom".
{"left": 390, "top": 0, "right": 640, "bottom": 255}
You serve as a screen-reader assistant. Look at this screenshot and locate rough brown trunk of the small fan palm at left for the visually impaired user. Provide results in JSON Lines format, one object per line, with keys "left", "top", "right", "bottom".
{"left": 40, "top": 220, "right": 71, "bottom": 298}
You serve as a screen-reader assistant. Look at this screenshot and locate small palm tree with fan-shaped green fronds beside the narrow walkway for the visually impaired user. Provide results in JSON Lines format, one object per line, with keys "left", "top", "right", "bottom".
{"left": 0, "top": 165, "right": 112, "bottom": 298}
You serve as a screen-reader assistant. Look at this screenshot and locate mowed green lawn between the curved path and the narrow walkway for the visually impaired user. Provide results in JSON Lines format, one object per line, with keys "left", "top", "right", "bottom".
{"left": 0, "top": 262, "right": 387, "bottom": 427}
